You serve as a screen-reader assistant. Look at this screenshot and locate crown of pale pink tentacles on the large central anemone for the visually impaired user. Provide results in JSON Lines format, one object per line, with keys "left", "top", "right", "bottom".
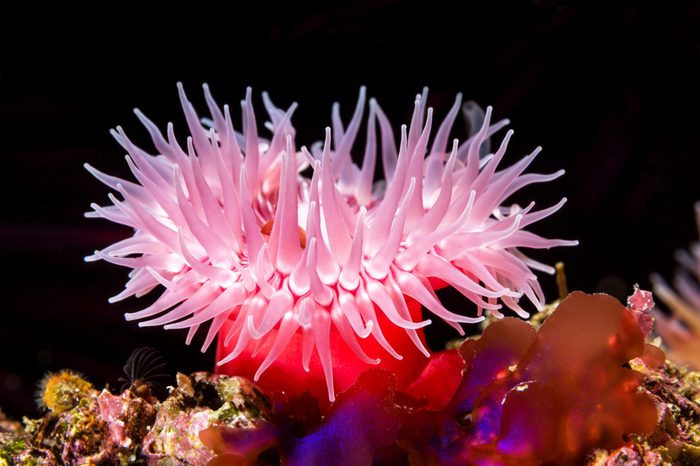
{"left": 86, "top": 85, "right": 576, "bottom": 400}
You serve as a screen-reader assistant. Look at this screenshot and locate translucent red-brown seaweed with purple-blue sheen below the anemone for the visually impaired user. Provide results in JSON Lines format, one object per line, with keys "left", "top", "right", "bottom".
{"left": 206, "top": 292, "right": 663, "bottom": 466}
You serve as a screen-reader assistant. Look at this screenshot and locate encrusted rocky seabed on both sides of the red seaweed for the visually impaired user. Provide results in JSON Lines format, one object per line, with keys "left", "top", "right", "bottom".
{"left": 0, "top": 358, "right": 700, "bottom": 466}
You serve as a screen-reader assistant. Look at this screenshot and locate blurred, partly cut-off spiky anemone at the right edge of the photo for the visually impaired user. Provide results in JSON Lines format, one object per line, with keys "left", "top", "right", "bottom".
{"left": 650, "top": 202, "right": 700, "bottom": 369}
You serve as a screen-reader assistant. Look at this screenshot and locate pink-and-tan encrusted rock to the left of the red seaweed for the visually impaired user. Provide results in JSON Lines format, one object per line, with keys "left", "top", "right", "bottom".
{"left": 0, "top": 372, "right": 271, "bottom": 466}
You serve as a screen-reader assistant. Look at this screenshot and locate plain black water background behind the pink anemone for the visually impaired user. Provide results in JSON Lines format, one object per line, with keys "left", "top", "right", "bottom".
{"left": 0, "top": 0, "right": 700, "bottom": 416}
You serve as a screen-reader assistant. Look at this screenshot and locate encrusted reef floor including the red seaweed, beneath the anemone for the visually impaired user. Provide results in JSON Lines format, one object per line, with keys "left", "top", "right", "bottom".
{"left": 0, "top": 292, "right": 700, "bottom": 466}
